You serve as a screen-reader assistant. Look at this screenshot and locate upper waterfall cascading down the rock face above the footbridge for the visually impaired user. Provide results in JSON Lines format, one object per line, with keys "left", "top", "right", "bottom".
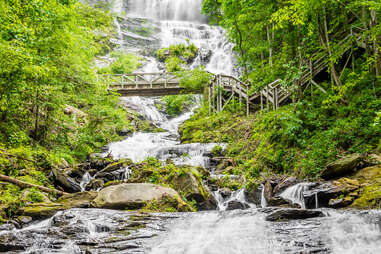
{"left": 107, "top": 0, "right": 237, "bottom": 75}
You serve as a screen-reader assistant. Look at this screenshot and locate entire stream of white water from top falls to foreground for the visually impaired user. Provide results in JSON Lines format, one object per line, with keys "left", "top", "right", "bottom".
{"left": 0, "top": 0, "right": 381, "bottom": 254}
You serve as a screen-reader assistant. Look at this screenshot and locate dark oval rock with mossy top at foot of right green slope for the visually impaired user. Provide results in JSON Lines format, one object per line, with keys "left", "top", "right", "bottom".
{"left": 321, "top": 153, "right": 365, "bottom": 180}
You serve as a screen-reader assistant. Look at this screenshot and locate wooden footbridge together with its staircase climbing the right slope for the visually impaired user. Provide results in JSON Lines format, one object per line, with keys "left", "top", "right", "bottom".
{"left": 98, "top": 33, "right": 359, "bottom": 114}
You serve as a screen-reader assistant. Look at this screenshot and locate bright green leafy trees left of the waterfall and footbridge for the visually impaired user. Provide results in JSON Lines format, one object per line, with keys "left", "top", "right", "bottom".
{"left": 0, "top": 0, "right": 132, "bottom": 163}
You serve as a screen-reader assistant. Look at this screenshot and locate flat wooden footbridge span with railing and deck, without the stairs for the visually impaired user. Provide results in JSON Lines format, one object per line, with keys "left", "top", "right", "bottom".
{"left": 98, "top": 72, "right": 194, "bottom": 97}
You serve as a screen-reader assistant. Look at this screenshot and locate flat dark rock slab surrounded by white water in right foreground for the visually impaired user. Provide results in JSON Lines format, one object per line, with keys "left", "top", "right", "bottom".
{"left": 266, "top": 209, "right": 324, "bottom": 221}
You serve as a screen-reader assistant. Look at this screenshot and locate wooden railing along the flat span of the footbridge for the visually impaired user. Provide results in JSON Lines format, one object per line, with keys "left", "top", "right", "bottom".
{"left": 98, "top": 72, "right": 180, "bottom": 90}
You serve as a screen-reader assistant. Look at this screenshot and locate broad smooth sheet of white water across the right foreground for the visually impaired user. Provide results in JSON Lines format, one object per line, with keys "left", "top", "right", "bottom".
{"left": 149, "top": 210, "right": 381, "bottom": 254}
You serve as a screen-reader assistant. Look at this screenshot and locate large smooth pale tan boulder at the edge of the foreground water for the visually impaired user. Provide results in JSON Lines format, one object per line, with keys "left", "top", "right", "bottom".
{"left": 92, "top": 183, "right": 179, "bottom": 209}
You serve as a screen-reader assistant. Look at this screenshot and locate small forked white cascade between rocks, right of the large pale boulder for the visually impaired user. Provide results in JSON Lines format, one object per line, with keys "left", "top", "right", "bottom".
{"left": 213, "top": 189, "right": 251, "bottom": 211}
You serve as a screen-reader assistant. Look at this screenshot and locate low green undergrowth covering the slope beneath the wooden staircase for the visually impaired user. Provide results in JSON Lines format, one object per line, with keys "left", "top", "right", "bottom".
{"left": 180, "top": 80, "right": 381, "bottom": 181}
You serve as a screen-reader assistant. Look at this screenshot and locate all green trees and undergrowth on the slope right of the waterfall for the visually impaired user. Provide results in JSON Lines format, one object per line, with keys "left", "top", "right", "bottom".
{"left": 182, "top": 0, "right": 381, "bottom": 181}
